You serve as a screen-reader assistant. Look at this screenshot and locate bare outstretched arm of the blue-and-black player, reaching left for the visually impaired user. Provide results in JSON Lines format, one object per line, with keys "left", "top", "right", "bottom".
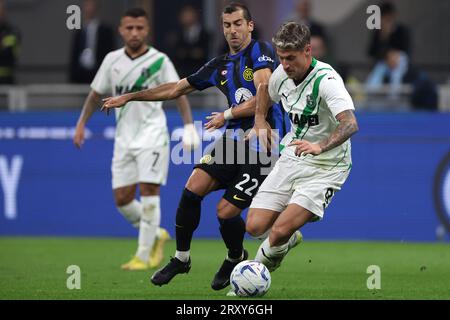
{"left": 102, "top": 79, "right": 195, "bottom": 111}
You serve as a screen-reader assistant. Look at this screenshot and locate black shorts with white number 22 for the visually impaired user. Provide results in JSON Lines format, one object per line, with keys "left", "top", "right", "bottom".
{"left": 195, "top": 137, "right": 273, "bottom": 210}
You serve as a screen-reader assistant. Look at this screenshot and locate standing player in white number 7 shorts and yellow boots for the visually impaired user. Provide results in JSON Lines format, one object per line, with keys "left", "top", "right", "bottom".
{"left": 74, "top": 8, "right": 200, "bottom": 270}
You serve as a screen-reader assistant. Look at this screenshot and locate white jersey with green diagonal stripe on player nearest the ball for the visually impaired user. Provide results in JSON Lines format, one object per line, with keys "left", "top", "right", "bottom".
{"left": 269, "top": 59, "right": 354, "bottom": 169}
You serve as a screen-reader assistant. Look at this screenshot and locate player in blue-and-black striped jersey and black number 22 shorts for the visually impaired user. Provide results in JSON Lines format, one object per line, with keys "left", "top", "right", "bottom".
{"left": 104, "top": 3, "right": 283, "bottom": 290}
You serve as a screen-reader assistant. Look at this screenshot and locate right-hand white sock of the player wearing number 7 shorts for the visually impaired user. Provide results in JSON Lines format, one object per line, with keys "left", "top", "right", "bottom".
{"left": 136, "top": 196, "right": 161, "bottom": 262}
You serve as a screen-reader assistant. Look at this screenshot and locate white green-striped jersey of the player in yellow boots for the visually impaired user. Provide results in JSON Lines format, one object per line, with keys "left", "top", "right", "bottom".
{"left": 91, "top": 47, "right": 180, "bottom": 148}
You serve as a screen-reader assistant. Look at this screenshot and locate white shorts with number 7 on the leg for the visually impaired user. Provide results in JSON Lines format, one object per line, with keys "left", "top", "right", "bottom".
{"left": 111, "top": 144, "right": 170, "bottom": 190}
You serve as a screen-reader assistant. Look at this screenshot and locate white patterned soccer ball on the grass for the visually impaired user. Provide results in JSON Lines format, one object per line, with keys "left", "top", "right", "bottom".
{"left": 230, "top": 260, "right": 271, "bottom": 297}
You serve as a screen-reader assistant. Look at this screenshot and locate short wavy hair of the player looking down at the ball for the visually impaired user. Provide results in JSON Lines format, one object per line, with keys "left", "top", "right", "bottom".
{"left": 272, "top": 21, "right": 311, "bottom": 50}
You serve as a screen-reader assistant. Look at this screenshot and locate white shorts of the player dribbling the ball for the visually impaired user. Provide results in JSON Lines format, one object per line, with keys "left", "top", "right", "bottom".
{"left": 250, "top": 155, "right": 350, "bottom": 219}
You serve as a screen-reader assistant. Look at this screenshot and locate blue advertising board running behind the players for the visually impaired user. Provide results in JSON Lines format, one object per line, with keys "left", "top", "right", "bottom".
{"left": 0, "top": 111, "right": 450, "bottom": 241}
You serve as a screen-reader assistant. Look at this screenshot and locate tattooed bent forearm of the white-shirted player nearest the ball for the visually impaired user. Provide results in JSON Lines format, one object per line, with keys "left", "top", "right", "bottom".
{"left": 289, "top": 110, "right": 359, "bottom": 156}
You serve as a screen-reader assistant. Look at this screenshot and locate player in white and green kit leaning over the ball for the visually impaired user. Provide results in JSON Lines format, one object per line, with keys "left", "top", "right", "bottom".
{"left": 247, "top": 22, "right": 358, "bottom": 271}
